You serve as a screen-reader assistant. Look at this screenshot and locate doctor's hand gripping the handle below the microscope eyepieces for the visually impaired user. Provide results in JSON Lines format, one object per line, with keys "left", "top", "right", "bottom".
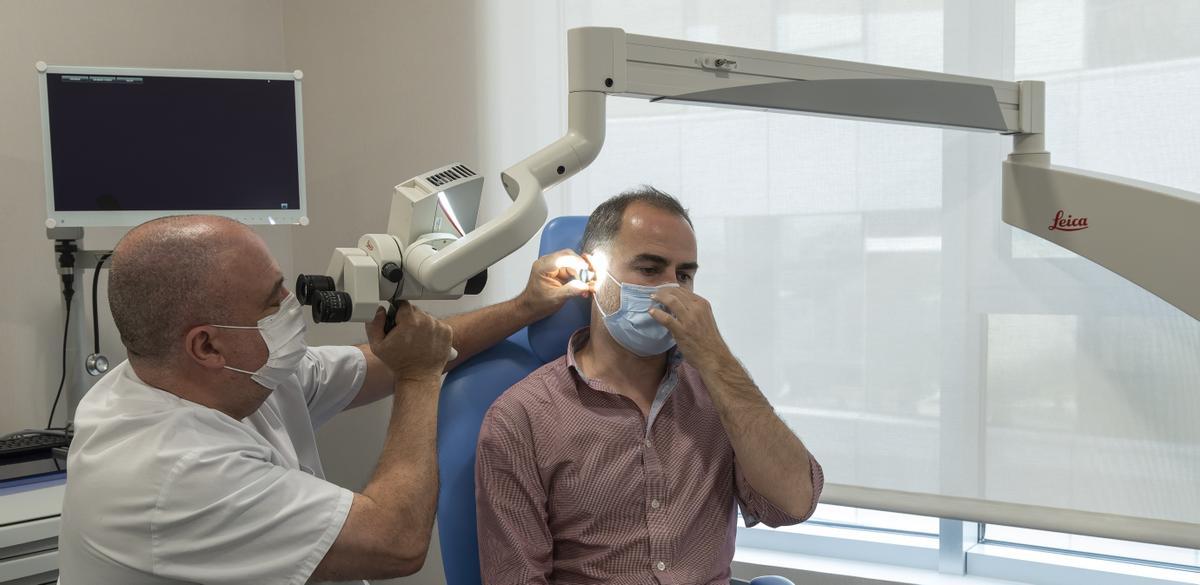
{"left": 367, "top": 301, "right": 454, "bottom": 380}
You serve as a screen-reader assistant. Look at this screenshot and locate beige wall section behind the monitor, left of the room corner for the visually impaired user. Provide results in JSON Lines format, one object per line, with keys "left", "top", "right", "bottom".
{"left": 0, "top": 0, "right": 292, "bottom": 432}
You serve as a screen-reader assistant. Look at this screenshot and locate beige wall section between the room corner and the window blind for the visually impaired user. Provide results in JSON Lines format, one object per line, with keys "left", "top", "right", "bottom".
{"left": 283, "top": 0, "right": 482, "bottom": 584}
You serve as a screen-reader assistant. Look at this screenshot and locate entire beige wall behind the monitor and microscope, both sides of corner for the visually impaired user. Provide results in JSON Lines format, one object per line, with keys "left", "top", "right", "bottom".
{"left": 0, "top": 0, "right": 479, "bottom": 583}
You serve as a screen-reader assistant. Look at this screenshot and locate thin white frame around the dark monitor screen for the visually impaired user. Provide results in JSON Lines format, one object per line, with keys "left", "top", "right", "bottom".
{"left": 37, "top": 62, "right": 308, "bottom": 228}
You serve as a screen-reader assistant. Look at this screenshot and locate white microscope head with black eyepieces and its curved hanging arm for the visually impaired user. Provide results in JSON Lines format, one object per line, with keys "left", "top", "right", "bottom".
{"left": 295, "top": 29, "right": 612, "bottom": 324}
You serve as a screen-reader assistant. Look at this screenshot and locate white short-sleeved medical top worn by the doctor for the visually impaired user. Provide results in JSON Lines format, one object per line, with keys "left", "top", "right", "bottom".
{"left": 59, "top": 348, "right": 366, "bottom": 585}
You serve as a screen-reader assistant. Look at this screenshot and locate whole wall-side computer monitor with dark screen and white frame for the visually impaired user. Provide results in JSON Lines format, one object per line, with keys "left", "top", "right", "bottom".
{"left": 37, "top": 64, "right": 308, "bottom": 228}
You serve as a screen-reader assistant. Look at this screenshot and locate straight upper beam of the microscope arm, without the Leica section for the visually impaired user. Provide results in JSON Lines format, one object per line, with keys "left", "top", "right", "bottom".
{"left": 590, "top": 28, "right": 1022, "bottom": 133}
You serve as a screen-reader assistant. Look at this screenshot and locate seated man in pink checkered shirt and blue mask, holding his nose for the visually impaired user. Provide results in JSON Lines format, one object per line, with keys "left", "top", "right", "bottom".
{"left": 475, "top": 187, "right": 823, "bottom": 585}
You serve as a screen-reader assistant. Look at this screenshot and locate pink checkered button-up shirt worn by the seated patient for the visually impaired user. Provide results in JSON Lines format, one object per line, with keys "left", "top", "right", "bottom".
{"left": 475, "top": 328, "right": 824, "bottom": 585}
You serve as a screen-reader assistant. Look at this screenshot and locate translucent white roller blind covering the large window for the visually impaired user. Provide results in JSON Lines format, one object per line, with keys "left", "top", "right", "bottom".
{"left": 545, "top": 0, "right": 1200, "bottom": 548}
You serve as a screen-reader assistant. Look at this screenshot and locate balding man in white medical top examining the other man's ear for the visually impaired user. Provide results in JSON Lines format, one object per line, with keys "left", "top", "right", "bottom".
{"left": 59, "top": 216, "right": 587, "bottom": 585}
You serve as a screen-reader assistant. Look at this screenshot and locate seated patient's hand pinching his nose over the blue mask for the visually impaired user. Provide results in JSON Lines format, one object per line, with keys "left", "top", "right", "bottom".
{"left": 649, "top": 288, "right": 733, "bottom": 369}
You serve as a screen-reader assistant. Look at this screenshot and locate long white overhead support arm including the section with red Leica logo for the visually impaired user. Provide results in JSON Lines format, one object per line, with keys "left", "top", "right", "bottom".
{"left": 525, "top": 28, "right": 1200, "bottom": 319}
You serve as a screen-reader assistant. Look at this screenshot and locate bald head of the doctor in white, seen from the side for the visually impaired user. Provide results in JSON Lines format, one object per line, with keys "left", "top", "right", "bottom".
{"left": 108, "top": 216, "right": 265, "bottom": 363}
